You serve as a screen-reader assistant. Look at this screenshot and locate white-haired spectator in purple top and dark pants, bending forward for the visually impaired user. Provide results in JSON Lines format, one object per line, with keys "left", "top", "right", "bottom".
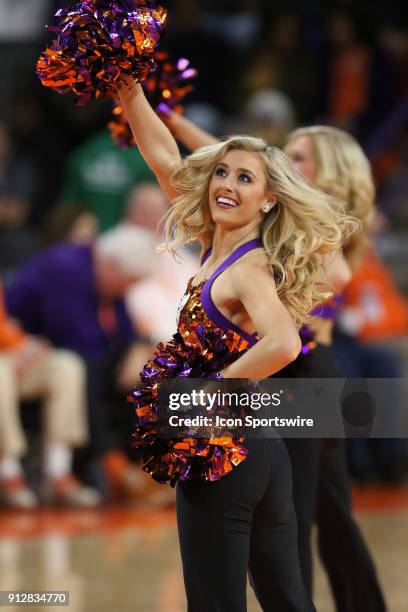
{"left": 3, "top": 227, "right": 170, "bottom": 496}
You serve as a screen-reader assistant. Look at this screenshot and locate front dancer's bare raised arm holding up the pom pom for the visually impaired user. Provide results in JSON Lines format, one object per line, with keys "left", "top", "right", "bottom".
{"left": 118, "top": 79, "right": 180, "bottom": 200}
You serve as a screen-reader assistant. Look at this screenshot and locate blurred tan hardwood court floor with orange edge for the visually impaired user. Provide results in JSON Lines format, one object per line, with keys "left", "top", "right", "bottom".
{"left": 0, "top": 489, "right": 408, "bottom": 612}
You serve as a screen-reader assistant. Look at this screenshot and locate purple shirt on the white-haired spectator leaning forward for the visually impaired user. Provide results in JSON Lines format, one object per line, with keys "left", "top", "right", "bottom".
{"left": 6, "top": 244, "right": 135, "bottom": 360}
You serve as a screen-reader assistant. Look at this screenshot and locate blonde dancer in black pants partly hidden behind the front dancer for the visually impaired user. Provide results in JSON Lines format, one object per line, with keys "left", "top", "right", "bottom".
{"left": 166, "top": 113, "right": 385, "bottom": 612}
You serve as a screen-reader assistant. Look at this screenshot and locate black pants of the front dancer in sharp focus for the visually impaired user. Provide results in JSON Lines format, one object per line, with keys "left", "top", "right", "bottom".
{"left": 177, "top": 439, "right": 315, "bottom": 612}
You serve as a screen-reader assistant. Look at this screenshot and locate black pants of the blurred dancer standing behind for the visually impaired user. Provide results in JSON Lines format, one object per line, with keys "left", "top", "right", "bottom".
{"left": 275, "top": 345, "right": 386, "bottom": 612}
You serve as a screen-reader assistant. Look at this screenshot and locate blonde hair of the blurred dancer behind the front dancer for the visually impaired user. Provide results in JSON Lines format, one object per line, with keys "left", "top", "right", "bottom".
{"left": 284, "top": 125, "right": 375, "bottom": 269}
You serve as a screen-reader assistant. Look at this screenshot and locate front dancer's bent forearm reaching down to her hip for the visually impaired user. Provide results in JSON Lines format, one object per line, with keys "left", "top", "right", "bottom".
{"left": 221, "top": 337, "right": 301, "bottom": 379}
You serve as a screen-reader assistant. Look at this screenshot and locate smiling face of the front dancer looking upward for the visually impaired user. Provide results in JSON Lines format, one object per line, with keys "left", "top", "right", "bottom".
{"left": 209, "top": 150, "right": 273, "bottom": 229}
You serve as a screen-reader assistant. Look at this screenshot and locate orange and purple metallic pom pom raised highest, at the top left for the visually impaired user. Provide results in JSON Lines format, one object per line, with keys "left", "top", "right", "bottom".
{"left": 37, "top": 0, "right": 166, "bottom": 104}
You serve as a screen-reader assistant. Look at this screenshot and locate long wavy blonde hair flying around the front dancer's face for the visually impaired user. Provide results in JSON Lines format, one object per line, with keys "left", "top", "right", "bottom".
{"left": 161, "top": 136, "right": 357, "bottom": 326}
